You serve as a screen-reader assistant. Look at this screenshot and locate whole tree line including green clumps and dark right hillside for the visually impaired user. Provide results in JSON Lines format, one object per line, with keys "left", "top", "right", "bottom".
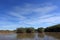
{"left": 16, "top": 24, "right": 60, "bottom": 33}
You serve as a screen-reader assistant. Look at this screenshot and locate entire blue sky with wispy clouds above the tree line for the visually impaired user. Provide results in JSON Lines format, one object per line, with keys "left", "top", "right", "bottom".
{"left": 0, "top": 0, "right": 60, "bottom": 30}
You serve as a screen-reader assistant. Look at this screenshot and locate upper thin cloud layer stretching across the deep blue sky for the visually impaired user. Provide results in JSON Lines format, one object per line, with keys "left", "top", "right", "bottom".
{"left": 9, "top": 4, "right": 58, "bottom": 20}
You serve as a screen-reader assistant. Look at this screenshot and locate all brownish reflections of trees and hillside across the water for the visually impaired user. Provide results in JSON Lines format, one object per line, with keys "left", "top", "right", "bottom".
{"left": 17, "top": 32, "right": 60, "bottom": 40}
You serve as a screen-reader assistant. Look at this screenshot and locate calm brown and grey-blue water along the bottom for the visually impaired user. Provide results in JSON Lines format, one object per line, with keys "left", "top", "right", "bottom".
{"left": 0, "top": 32, "right": 60, "bottom": 40}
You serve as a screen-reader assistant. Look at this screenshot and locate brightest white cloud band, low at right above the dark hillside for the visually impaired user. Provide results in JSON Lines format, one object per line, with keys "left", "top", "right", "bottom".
{"left": 26, "top": 16, "right": 60, "bottom": 25}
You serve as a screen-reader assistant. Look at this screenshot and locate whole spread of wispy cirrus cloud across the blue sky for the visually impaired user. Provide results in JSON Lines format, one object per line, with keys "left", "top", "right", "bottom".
{"left": 1, "top": 3, "right": 60, "bottom": 28}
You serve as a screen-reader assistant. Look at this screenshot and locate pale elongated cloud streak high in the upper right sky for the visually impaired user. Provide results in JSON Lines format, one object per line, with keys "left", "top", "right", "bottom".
{"left": 34, "top": 6, "right": 57, "bottom": 14}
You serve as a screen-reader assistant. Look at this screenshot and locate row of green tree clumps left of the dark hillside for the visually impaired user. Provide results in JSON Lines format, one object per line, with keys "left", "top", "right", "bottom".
{"left": 16, "top": 28, "right": 44, "bottom": 33}
